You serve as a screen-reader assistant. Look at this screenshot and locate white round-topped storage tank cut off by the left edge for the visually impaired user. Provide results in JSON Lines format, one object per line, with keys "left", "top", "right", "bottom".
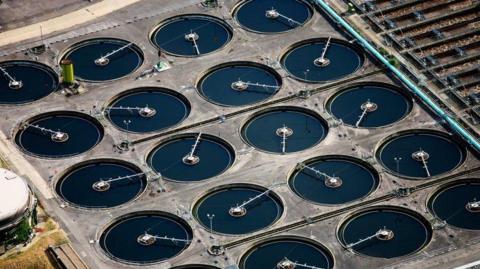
{"left": 0, "top": 168, "right": 33, "bottom": 231}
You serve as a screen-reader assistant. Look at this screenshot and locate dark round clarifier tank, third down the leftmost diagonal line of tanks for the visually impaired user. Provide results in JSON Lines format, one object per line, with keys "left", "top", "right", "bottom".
{"left": 55, "top": 159, "right": 147, "bottom": 208}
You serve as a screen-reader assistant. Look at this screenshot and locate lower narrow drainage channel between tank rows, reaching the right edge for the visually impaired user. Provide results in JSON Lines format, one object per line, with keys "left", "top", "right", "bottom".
{"left": 221, "top": 164, "right": 480, "bottom": 249}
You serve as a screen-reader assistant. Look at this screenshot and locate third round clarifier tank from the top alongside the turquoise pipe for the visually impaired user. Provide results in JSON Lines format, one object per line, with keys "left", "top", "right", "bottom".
{"left": 327, "top": 82, "right": 413, "bottom": 128}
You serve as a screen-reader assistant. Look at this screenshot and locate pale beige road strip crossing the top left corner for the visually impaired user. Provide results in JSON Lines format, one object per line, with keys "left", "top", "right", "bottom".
{"left": 0, "top": 0, "right": 141, "bottom": 47}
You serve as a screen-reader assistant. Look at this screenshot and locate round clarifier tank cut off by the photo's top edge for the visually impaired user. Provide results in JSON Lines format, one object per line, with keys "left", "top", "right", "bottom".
{"left": 233, "top": 0, "right": 313, "bottom": 34}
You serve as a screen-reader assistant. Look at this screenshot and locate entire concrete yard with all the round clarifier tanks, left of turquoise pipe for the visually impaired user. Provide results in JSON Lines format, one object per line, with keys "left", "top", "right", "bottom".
{"left": 0, "top": 0, "right": 480, "bottom": 269}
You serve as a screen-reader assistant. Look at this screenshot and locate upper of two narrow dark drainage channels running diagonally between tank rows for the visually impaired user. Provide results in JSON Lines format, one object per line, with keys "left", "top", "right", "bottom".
{"left": 131, "top": 68, "right": 384, "bottom": 145}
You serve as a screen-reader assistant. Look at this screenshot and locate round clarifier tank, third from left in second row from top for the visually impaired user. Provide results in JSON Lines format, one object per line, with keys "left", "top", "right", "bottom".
{"left": 197, "top": 62, "right": 282, "bottom": 106}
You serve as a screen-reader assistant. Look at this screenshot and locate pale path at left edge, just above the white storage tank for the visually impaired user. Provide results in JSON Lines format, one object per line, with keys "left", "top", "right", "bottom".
{"left": 0, "top": 131, "right": 53, "bottom": 199}
